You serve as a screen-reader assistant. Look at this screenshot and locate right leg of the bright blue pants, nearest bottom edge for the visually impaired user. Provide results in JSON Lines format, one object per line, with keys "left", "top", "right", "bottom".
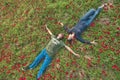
{"left": 37, "top": 53, "right": 52, "bottom": 79}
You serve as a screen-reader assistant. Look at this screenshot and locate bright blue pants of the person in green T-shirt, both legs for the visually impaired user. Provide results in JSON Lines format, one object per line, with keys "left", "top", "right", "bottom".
{"left": 29, "top": 49, "right": 52, "bottom": 79}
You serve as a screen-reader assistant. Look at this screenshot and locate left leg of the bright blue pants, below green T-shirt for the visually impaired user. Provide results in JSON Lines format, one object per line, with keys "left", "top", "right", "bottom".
{"left": 29, "top": 49, "right": 45, "bottom": 69}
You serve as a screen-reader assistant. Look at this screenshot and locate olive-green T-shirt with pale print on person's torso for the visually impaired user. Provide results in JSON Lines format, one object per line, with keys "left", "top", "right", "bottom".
{"left": 46, "top": 37, "right": 64, "bottom": 56}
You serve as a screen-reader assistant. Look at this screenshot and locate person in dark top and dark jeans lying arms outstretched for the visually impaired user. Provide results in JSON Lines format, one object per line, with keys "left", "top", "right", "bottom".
{"left": 60, "top": 4, "right": 104, "bottom": 45}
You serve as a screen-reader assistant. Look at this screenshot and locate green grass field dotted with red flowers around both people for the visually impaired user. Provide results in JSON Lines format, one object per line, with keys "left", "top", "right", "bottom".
{"left": 0, "top": 0, "right": 120, "bottom": 80}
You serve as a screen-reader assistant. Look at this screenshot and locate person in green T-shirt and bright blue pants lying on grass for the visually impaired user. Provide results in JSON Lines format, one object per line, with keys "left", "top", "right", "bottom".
{"left": 22, "top": 26, "right": 80, "bottom": 80}
